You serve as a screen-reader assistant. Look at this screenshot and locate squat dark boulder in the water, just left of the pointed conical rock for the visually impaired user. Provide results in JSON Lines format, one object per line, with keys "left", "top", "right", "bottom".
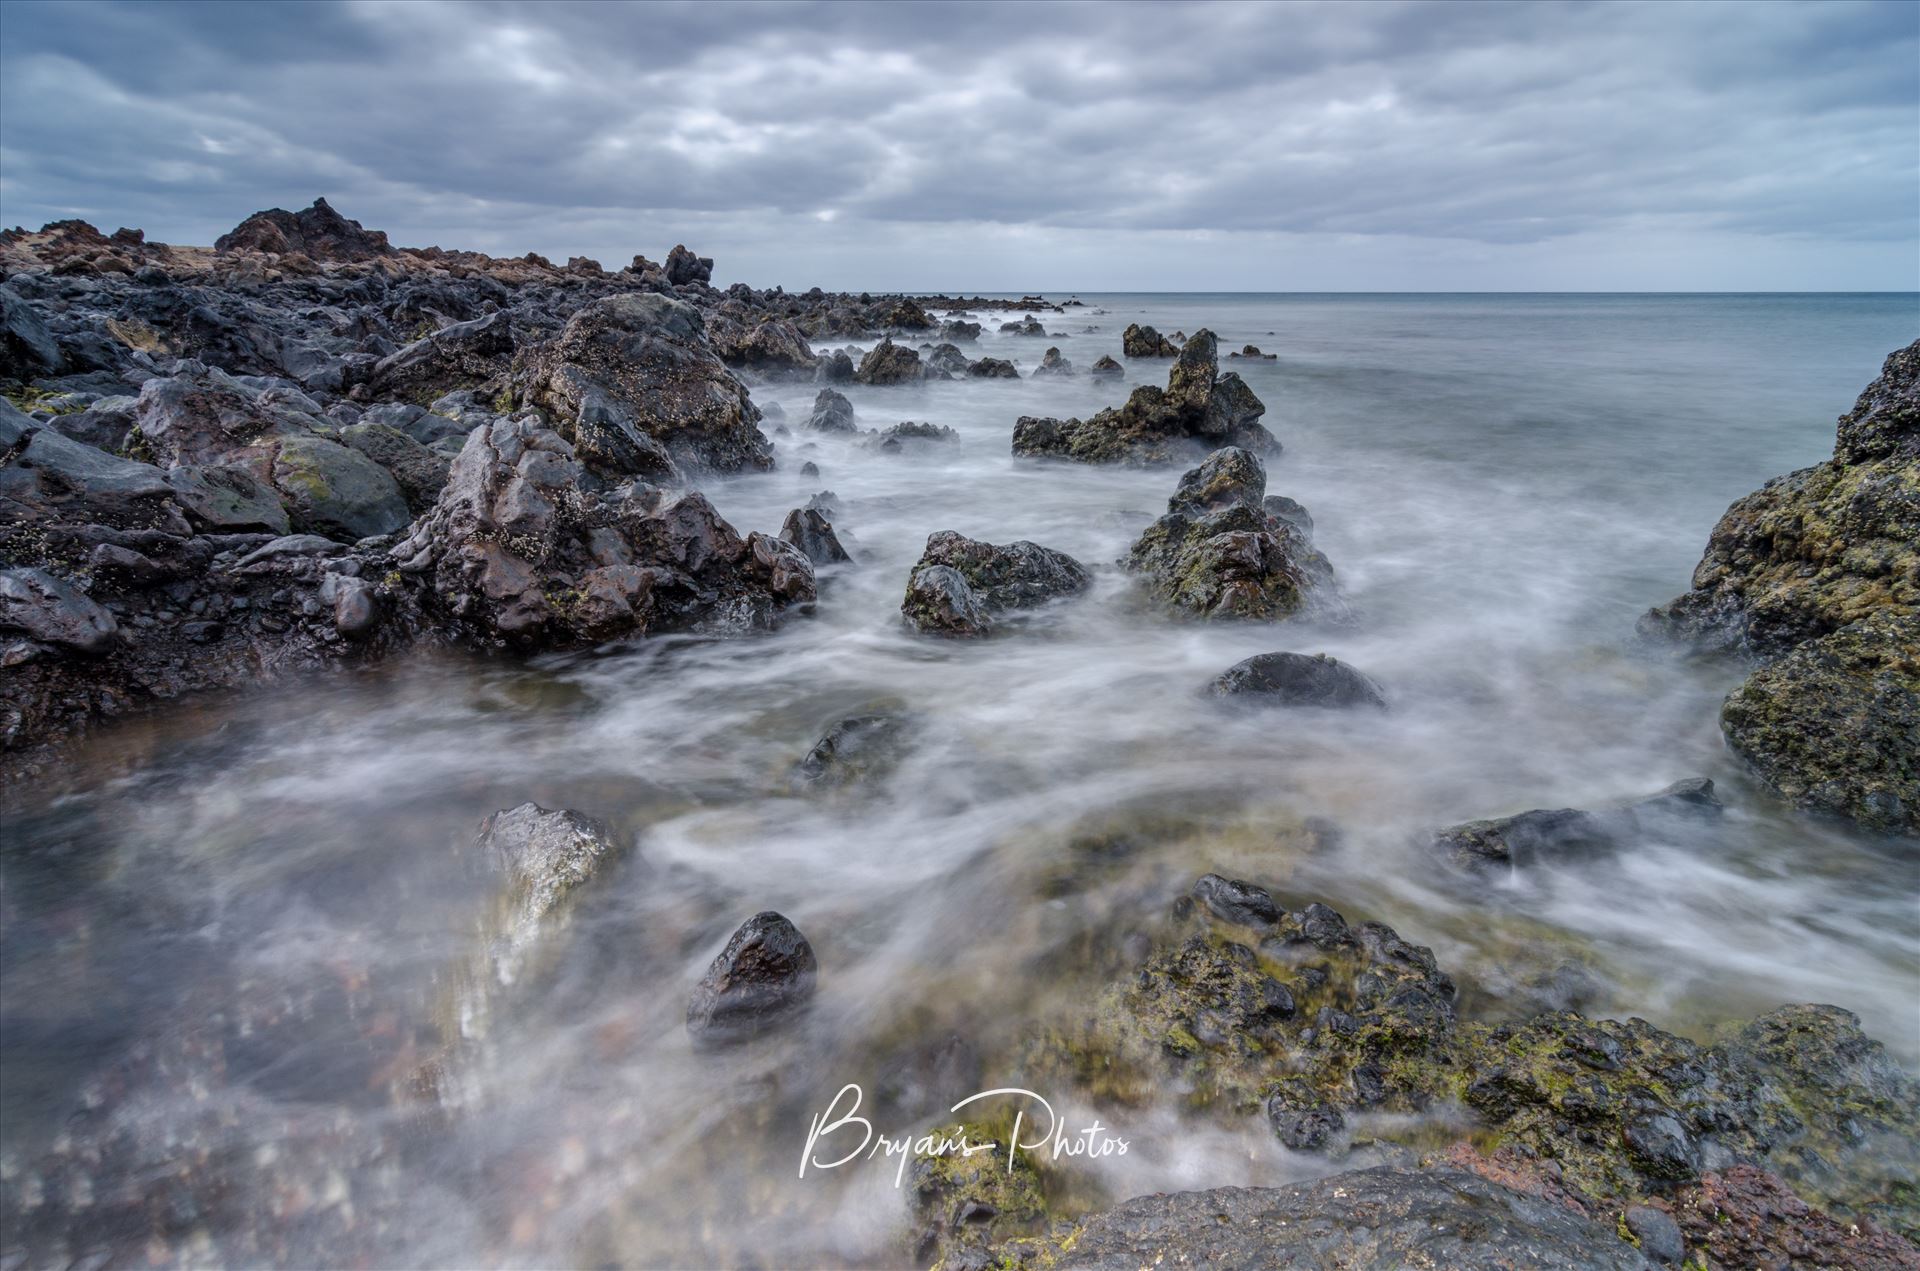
{"left": 900, "top": 530, "right": 1092, "bottom": 636}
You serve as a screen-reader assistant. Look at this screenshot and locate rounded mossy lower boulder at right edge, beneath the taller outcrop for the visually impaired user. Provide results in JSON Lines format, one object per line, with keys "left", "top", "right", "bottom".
{"left": 1720, "top": 609, "right": 1920, "bottom": 833}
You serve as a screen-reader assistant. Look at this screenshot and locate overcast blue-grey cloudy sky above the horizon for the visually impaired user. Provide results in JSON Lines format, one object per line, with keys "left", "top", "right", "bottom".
{"left": 0, "top": 0, "right": 1920, "bottom": 292}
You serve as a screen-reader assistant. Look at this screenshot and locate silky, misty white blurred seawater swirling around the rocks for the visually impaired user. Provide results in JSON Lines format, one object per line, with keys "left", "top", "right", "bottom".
{"left": 0, "top": 294, "right": 1920, "bottom": 1265}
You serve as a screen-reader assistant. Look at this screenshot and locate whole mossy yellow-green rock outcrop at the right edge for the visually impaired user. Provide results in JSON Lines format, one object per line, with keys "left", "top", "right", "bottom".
{"left": 1640, "top": 340, "right": 1920, "bottom": 833}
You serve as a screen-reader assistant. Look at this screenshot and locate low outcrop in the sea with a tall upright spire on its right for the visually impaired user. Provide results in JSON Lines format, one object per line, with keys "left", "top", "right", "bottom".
{"left": 1014, "top": 330, "right": 1279, "bottom": 465}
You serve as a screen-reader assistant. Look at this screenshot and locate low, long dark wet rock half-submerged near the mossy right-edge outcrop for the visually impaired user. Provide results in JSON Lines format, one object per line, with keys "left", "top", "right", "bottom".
{"left": 1432, "top": 778, "right": 1720, "bottom": 868}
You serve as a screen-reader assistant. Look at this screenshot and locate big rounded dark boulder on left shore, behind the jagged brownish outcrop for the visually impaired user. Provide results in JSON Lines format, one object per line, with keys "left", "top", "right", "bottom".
{"left": 530, "top": 294, "right": 774, "bottom": 480}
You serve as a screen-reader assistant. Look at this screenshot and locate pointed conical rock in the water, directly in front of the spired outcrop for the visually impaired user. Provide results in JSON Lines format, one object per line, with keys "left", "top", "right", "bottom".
{"left": 1123, "top": 447, "right": 1346, "bottom": 620}
